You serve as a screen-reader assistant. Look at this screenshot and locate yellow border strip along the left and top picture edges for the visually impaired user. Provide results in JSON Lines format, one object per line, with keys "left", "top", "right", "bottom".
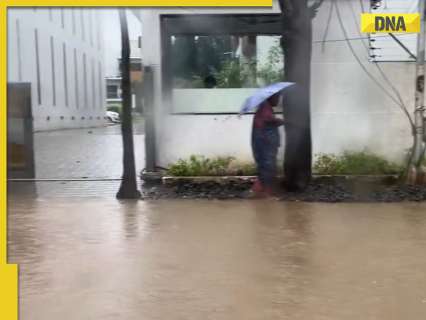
{"left": 0, "top": 0, "right": 272, "bottom": 320}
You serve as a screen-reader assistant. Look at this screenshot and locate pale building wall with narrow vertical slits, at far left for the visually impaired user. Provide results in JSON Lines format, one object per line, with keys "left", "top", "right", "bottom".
{"left": 8, "top": 8, "right": 105, "bottom": 130}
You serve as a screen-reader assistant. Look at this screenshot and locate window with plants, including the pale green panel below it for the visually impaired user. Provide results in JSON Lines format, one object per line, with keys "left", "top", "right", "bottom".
{"left": 166, "top": 34, "right": 284, "bottom": 113}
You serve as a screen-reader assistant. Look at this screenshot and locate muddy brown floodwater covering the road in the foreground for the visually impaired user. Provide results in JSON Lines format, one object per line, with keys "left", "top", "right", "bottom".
{"left": 9, "top": 198, "right": 426, "bottom": 320}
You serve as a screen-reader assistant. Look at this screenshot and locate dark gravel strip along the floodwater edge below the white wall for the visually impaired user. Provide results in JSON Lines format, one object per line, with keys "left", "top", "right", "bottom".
{"left": 142, "top": 177, "right": 426, "bottom": 202}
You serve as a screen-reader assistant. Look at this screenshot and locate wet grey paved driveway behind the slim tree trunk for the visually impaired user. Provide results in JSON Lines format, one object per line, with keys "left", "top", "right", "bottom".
{"left": 34, "top": 119, "right": 145, "bottom": 179}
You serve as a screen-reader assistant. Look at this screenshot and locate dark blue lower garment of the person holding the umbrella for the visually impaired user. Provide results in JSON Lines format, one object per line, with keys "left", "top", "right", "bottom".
{"left": 252, "top": 127, "right": 280, "bottom": 187}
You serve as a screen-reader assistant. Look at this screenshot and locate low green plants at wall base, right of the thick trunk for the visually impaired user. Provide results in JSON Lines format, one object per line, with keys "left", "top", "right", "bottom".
{"left": 313, "top": 151, "right": 403, "bottom": 175}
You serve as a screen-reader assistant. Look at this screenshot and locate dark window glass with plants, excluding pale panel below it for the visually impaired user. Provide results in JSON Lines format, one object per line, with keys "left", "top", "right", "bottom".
{"left": 170, "top": 36, "right": 284, "bottom": 89}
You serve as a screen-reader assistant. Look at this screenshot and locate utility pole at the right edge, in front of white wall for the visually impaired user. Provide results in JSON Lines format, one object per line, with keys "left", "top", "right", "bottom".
{"left": 408, "top": 0, "right": 426, "bottom": 184}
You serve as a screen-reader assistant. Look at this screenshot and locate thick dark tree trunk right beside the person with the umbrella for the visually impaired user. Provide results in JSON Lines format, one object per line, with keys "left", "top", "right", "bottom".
{"left": 281, "top": 0, "right": 312, "bottom": 191}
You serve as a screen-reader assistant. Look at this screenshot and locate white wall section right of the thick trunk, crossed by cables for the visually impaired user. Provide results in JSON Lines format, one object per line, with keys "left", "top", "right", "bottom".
{"left": 311, "top": 0, "right": 415, "bottom": 160}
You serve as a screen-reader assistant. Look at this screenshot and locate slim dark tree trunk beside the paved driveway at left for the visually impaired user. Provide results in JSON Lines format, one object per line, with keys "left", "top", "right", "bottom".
{"left": 117, "top": 9, "right": 140, "bottom": 199}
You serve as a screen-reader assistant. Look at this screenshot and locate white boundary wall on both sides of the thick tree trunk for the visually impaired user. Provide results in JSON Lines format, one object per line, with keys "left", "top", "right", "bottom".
{"left": 140, "top": 1, "right": 414, "bottom": 166}
